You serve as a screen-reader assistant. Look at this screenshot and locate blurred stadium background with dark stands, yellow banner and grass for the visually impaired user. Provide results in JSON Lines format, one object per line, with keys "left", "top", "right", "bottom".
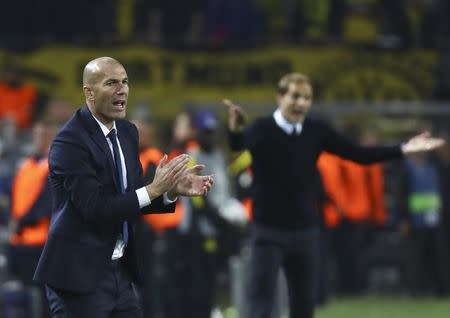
{"left": 0, "top": 0, "right": 450, "bottom": 318}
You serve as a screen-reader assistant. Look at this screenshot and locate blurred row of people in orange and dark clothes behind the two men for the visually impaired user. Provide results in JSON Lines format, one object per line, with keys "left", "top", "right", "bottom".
{"left": 0, "top": 59, "right": 450, "bottom": 318}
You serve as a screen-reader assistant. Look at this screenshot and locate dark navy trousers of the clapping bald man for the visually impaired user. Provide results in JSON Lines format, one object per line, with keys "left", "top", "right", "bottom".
{"left": 46, "top": 260, "right": 142, "bottom": 318}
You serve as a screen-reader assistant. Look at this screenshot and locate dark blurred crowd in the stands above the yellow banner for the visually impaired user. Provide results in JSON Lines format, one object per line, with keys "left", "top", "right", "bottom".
{"left": 0, "top": 0, "right": 450, "bottom": 50}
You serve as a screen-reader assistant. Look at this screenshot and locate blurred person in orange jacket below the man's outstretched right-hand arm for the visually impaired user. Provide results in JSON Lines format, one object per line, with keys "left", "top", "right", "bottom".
{"left": 318, "top": 130, "right": 387, "bottom": 295}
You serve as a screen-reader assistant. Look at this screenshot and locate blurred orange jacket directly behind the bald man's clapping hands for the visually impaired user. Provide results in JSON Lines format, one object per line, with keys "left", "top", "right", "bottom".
{"left": 139, "top": 148, "right": 184, "bottom": 233}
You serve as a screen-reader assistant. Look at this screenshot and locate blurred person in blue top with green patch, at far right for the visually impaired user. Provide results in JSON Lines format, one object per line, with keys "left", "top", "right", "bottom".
{"left": 400, "top": 153, "right": 449, "bottom": 295}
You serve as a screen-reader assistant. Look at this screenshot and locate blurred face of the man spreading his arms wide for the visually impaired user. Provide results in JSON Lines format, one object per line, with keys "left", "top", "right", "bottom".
{"left": 277, "top": 82, "right": 312, "bottom": 123}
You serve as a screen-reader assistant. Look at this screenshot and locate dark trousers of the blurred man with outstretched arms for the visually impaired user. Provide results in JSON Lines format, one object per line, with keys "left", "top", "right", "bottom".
{"left": 247, "top": 225, "right": 320, "bottom": 318}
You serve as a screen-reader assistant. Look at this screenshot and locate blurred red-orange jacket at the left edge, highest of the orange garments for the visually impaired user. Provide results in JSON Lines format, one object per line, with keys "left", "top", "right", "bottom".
{"left": 0, "top": 83, "right": 37, "bottom": 129}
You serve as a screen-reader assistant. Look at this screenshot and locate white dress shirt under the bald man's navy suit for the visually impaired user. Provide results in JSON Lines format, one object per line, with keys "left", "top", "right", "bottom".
{"left": 92, "top": 115, "right": 177, "bottom": 260}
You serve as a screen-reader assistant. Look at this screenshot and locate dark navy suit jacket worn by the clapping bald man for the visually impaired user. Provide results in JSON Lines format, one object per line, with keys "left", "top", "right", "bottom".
{"left": 34, "top": 106, "right": 175, "bottom": 292}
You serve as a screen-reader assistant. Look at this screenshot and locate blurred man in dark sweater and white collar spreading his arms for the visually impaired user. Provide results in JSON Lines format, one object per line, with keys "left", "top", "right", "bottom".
{"left": 224, "top": 73, "right": 443, "bottom": 318}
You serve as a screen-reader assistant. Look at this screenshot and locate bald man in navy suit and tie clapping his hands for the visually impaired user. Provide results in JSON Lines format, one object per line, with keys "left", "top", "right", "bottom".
{"left": 35, "top": 57, "right": 213, "bottom": 318}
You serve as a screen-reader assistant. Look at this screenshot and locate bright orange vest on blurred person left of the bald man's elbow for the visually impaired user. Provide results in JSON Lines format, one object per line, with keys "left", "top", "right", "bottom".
{"left": 10, "top": 158, "right": 50, "bottom": 246}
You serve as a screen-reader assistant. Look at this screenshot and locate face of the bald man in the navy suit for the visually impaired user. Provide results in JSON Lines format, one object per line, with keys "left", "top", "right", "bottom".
{"left": 85, "top": 63, "right": 129, "bottom": 127}
